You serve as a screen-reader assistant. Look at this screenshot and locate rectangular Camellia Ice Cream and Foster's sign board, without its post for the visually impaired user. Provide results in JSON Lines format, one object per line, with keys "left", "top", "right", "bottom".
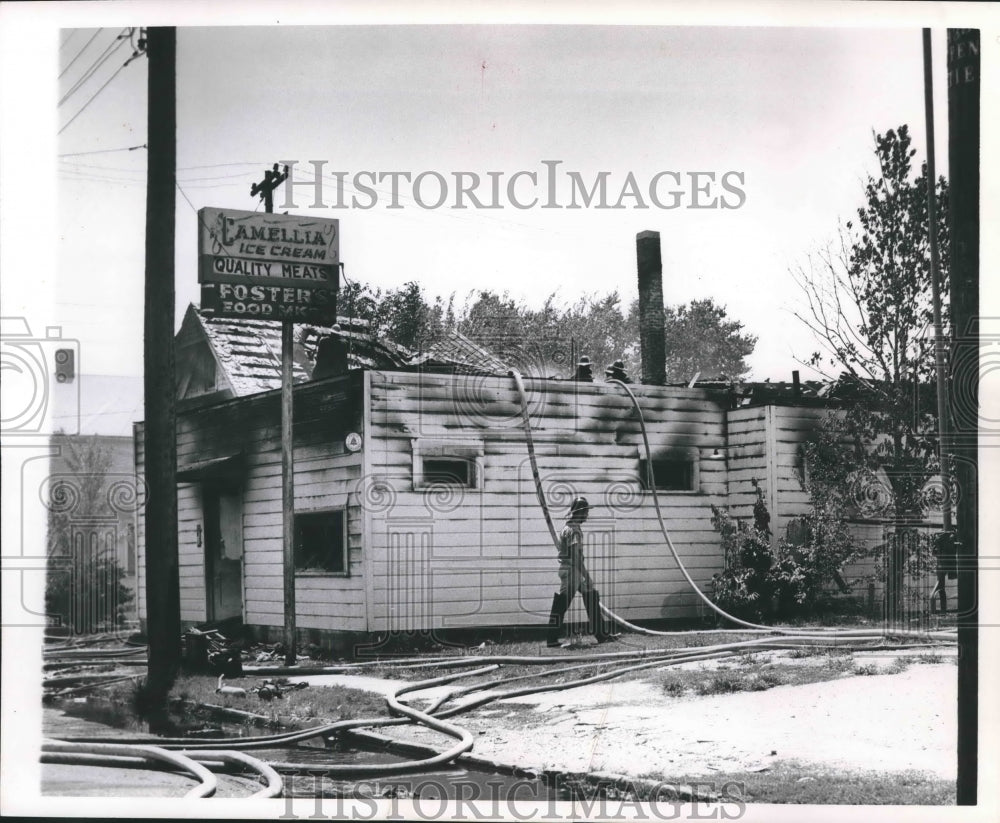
{"left": 198, "top": 208, "right": 340, "bottom": 323}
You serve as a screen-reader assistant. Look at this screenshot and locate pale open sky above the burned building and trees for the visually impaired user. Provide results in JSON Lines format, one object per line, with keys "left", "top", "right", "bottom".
{"left": 15, "top": 8, "right": 980, "bottom": 380}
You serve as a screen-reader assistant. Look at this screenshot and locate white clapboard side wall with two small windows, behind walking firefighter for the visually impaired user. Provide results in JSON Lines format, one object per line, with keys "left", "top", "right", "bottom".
{"left": 366, "top": 372, "right": 726, "bottom": 631}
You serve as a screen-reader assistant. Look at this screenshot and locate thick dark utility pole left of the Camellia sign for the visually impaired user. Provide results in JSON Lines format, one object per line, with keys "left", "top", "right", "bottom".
{"left": 144, "top": 27, "right": 181, "bottom": 725}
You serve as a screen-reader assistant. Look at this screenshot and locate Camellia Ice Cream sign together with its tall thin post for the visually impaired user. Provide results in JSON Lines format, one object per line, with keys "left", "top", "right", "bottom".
{"left": 198, "top": 182, "right": 340, "bottom": 666}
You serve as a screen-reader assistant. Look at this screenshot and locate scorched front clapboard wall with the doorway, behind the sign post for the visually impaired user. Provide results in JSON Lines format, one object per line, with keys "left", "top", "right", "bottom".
{"left": 136, "top": 374, "right": 365, "bottom": 631}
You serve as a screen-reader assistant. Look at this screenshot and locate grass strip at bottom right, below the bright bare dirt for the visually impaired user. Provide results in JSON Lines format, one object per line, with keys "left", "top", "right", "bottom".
{"left": 636, "top": 760, "right": 955, "bottom": 806}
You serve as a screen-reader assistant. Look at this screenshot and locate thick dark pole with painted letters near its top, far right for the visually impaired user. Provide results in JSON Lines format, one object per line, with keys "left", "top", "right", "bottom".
{"left": 948, "top": 29, "right": 995, "bottom": 806}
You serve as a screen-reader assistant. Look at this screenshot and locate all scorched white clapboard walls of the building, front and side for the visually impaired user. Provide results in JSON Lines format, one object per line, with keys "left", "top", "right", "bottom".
{"left": 136, "top": 362, "right": 924, "bottom": 632}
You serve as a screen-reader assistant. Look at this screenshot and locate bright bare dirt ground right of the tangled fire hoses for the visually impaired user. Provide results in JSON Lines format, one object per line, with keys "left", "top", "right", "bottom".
{"left": 286, "top": 656, "right": 957, "bottom": 781}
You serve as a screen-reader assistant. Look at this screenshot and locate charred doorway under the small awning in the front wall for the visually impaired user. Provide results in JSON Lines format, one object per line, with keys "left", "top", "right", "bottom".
{"left": 203, "top": 485, "right": 243, "bottom": 623}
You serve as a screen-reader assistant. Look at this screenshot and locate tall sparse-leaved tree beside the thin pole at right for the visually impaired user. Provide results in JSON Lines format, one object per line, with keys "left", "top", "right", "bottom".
{"left": 793, "top": 125, "right": 948, "bottom": 516}
